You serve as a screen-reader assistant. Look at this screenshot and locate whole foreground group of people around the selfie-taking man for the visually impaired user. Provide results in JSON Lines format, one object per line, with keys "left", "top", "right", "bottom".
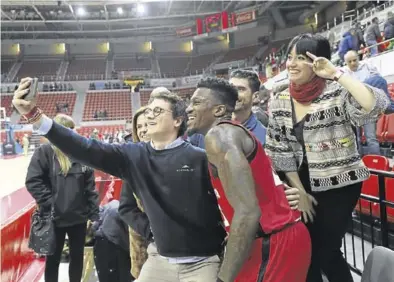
{"left": 13, "top": 31, "right": 391, "bottom": 282}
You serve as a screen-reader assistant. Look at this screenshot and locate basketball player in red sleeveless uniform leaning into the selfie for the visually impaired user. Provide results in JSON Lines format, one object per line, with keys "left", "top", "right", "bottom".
{"left": 186, "top": 78, "right": 311, "bottom": 282}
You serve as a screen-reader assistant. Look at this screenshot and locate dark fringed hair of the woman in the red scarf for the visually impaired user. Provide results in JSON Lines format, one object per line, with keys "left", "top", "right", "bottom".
{"left": 286, "top": 33, "right": 331, "bottom": 60}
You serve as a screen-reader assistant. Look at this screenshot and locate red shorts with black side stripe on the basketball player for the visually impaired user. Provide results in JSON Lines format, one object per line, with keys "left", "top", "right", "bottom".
{"left": 235, "top": 222, "right": 311, "bottom": 282}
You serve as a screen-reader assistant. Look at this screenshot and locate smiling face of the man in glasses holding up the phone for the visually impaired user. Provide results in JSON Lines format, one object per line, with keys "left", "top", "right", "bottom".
{"left": 144, "top": 99, "right": 182, "bottom": 141}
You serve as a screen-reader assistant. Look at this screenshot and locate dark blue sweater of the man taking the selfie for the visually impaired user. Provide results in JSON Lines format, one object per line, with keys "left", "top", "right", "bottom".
{"left": 46, "top": 122, "right": 225, "bottom": 257}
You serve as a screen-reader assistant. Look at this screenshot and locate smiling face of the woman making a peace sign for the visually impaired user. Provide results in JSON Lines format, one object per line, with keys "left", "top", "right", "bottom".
{"left": 286, "top": 46, "right": 315, "bottom": 85}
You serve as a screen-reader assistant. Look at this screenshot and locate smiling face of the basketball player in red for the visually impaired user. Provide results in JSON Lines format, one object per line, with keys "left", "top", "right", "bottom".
{"left": 186, "top": 88, "right": 217, "bottom": 135}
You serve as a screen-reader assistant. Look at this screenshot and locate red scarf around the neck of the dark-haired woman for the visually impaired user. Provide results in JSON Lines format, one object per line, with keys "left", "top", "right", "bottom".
{"left": 289, "top": 75, "right": 326, "bottom": 104}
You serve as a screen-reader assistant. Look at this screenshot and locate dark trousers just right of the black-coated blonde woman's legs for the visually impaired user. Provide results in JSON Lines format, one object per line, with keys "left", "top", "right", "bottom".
{"left": 93, "top": 237, "right": 134, "bottom": 282}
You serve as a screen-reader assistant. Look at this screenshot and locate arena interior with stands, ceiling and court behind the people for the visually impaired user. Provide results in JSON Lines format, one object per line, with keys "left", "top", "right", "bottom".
{"left": 0, "top": 0, "right": 394, "bottom": 282}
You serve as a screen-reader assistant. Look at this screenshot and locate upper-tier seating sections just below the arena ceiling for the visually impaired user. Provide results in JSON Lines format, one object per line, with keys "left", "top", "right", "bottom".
{"left": 1, "top": 45, "right": 261, "bottom": 81}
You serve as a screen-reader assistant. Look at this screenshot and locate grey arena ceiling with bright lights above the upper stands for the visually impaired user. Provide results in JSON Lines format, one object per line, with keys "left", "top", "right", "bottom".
{"left": 0, "top": 0, "right": 332, "bottom": 40}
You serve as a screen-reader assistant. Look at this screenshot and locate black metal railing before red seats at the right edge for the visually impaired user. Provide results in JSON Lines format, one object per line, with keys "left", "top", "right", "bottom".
{"left": 343, "top": 169, "right": 394, "bottom": 276}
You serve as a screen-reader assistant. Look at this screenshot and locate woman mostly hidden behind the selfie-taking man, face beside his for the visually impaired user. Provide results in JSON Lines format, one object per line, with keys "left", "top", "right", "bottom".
{"left": 122, "top": 107, "right": 152, "bottom": 278}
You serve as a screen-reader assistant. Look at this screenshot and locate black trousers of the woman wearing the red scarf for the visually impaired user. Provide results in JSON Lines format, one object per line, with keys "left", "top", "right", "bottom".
{"left": 299, "top": 164, "right": 362, "bottom": 282}
